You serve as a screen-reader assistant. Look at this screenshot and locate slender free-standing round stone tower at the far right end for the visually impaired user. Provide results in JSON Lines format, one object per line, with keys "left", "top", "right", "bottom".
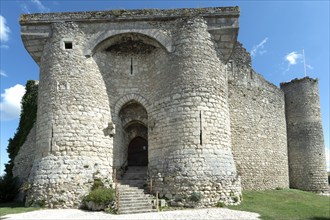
{"left": 281, "top": 77, "right": 328, "bottom": 192}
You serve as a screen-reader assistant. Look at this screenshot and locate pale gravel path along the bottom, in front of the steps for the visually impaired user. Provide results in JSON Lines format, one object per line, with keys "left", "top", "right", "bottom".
{"left": 1, "top": 208, "right": 259, "bottom": 220}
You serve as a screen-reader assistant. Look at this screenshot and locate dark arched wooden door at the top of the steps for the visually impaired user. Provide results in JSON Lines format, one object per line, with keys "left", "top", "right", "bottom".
{"left": 128, "top": 137, "right": 148, "bottom": 166}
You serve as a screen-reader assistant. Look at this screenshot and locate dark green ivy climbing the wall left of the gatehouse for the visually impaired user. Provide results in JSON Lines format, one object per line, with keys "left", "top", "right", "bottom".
{"left": 0, "top": 80, "right": 38, "bottom": 202}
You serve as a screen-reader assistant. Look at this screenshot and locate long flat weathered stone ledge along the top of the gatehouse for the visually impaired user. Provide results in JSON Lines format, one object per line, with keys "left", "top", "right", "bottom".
{"left": 20, "top": 6, "right": 239, "bottom": 24}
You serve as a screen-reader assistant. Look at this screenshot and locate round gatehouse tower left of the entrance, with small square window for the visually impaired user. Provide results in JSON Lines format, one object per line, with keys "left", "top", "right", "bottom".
{"left": 27, "top": 22, "right": 113, "bottom": 207}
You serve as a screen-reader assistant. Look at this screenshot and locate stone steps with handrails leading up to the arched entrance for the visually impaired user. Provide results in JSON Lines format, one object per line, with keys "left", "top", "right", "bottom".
{"left": 118, "top": 166, "right": 155, "bottom": 214}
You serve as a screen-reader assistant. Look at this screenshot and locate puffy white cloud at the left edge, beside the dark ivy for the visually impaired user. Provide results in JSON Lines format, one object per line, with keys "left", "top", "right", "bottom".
{"left": 0, "top": 84, "right": 25, "bottom": 121}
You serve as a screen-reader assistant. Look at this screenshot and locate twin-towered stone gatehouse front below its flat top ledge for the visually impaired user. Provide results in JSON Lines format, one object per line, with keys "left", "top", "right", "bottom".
{"left": 21, "top": 10, "right": 241, "bottom": 207}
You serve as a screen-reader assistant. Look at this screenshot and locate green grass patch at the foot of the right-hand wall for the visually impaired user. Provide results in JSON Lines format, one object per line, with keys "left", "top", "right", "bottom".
{"left": 228, "top": 189, "right": 330, "bottom": 220}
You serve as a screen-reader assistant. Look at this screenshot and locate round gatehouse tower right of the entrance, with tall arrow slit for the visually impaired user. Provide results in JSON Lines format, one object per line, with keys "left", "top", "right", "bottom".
{"left": 149, "top": 18, "right": 241, "bottom": 205}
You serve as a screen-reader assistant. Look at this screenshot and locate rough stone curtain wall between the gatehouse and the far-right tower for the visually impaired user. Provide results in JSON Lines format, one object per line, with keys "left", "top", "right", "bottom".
{"left": 227, "top": 42, "right": 289, "bottom": 190}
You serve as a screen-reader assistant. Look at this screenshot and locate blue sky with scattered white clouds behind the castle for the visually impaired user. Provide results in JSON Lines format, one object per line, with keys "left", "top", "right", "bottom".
{"left": 0, "top": 0, "right": 330, "bottom": 175}
